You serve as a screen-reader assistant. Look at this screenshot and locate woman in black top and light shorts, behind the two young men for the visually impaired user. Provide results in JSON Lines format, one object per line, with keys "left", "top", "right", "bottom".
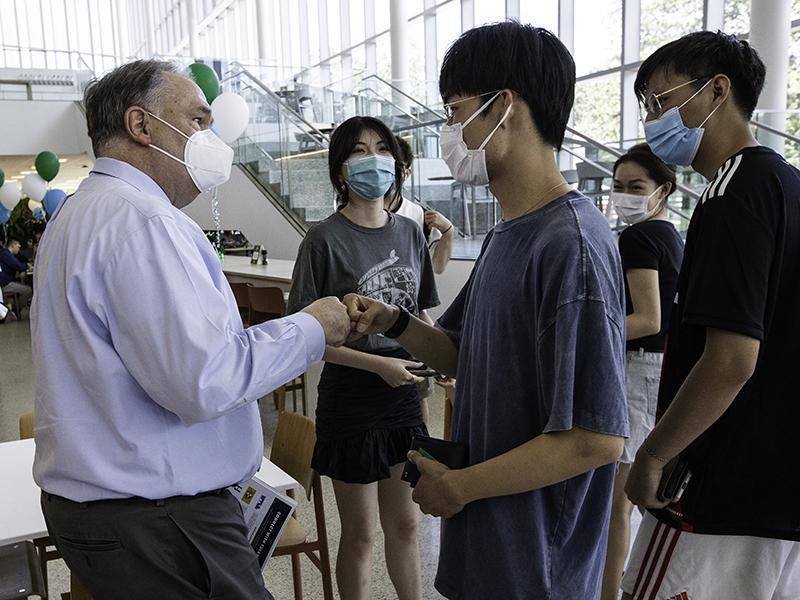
{"left": 602, "top": 144, "right": 683, "bottom": 600}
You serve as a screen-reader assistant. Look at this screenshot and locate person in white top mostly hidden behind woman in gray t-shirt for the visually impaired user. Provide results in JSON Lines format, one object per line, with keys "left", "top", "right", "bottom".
{"left": 383, "top": 135, "right": 455, "bottom": 275}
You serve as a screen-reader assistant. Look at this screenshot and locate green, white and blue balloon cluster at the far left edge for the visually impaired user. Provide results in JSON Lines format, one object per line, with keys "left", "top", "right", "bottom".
{"left": 0, "top": 150, "right": 66, "bottom": 225}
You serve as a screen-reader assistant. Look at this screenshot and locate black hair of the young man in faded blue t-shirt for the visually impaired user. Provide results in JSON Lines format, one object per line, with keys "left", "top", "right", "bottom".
{"left": 439, "top": 21, "right": 575, "bottom": 150}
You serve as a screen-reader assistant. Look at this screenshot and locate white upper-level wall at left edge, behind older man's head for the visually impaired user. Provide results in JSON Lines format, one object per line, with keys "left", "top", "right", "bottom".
{"left": 0, "top": 100, "right": 91, "bottom": 156}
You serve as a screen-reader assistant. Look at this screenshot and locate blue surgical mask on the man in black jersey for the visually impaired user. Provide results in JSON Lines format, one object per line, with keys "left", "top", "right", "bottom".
{"left": 644, "top": 79, "right": 722, "bottom": 167}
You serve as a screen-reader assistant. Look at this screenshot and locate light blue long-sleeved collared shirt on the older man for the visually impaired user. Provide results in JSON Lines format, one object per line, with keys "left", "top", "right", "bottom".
{"left": 31, "top": 158, "right": 325, "bottom": 502}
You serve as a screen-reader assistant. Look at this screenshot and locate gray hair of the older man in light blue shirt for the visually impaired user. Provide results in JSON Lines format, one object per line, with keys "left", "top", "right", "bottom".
{"left": 83, "top": 60, "right": 180, "bottom": 156}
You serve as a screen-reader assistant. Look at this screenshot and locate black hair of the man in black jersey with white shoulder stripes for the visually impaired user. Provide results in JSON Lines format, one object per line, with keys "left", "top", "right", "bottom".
{"left": 633, "top": 31, "right": 767, "bottom": 120}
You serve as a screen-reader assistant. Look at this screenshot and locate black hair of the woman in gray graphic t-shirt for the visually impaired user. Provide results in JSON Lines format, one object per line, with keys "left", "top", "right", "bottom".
{"left": 328, "top": 117, "right": 404, "bottom": 210}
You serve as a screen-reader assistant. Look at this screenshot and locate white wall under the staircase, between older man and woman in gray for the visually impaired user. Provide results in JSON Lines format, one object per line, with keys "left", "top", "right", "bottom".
{"left": 183, "top": 166, "right": 303, "bottom": 260}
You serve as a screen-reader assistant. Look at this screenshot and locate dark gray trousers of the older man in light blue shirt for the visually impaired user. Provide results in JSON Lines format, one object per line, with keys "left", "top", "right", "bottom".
{"left": 42, "top": 490, "right": 272, "bottom": 600}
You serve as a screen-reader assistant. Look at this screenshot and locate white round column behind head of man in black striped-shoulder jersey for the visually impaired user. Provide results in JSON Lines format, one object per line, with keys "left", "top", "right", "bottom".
{"left": 750, "top": 0, "right": 792, "bottom": 154}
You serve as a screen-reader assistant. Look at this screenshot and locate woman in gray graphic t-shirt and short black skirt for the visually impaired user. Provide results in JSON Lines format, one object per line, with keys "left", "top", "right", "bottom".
{"left": 289, "top": 117, "right": 439, "bottom": 598}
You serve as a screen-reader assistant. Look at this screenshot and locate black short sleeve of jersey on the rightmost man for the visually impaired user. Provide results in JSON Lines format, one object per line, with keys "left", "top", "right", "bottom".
{"left": 683, "top": 192, "right": 775, "bottom": 340}
